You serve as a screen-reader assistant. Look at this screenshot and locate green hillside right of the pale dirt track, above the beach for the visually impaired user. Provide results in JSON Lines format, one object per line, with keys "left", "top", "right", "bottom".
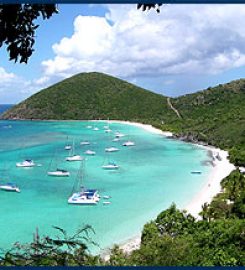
{"left": 167, "top": 79, "right": 245, "bottom": 165}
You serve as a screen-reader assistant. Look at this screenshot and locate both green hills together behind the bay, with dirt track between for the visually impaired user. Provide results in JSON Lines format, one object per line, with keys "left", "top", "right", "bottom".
{"left": 1, "top": 72, "right": 245, "bottom": 166}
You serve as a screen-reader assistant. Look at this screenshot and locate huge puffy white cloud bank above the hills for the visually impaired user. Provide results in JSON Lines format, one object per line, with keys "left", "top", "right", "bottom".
{"left": 39, "top": 5, "right": 245, "bottom": 78}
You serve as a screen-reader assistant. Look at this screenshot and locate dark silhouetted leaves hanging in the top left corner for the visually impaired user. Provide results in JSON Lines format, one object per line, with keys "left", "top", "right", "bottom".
{"left": 0, "top": 4, "right": 58, "bottom": 63}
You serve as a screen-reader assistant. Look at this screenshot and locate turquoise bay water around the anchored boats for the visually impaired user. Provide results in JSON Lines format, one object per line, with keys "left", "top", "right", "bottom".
{"left": 0, "top": 121, "right": 211, "bottom": 252}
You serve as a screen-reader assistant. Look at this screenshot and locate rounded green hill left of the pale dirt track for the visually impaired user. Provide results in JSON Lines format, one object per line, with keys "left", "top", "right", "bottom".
{"left": 2, "top": 72, "right": 178, "bottom": 121}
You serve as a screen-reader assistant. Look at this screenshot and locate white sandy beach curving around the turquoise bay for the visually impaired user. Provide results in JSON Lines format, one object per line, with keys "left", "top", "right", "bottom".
{"left": 99, "top": 120, "right": 235, "bottom": 255}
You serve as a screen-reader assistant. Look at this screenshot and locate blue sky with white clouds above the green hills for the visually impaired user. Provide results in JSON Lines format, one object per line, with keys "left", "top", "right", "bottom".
{"left": 0, "top": 4, "right": 245, "bottom": 104}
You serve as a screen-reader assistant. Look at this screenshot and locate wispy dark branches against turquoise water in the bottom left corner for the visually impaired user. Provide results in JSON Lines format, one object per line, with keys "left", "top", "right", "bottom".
{"left": 0, "top": 226, "right": 99, "bottom": 266}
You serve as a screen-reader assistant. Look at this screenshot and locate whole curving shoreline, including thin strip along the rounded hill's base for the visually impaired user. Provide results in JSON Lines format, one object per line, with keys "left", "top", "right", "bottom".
{"left": 1, "top": 119, "right": 235, "bottom": 255}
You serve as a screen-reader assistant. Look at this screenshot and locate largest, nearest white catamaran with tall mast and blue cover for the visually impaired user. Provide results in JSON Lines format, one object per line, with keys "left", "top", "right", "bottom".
{"left": 68, "top": 162, "right": 100, "bottom": 205}
